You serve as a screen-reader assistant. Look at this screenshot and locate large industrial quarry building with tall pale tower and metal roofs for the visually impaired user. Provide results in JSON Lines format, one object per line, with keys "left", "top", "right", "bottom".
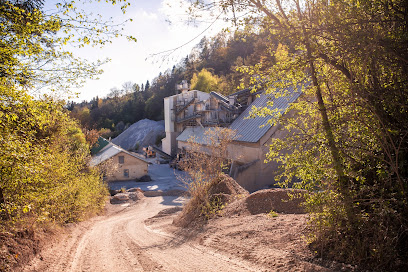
{"left": 162, "top": 81, "right": 301, "bottom": 191}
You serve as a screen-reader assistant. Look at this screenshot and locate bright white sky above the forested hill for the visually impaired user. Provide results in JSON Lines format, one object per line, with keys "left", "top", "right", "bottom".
{"left": 53, "top": 0, "right": 227, "bottom": 102}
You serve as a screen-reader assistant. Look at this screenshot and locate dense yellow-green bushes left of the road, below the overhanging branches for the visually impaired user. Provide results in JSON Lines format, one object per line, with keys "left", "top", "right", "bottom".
{"left": 0, "top": 83, "right": 107, "bottom": 223}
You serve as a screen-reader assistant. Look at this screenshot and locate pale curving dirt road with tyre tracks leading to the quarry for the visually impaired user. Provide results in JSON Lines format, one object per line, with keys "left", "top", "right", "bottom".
{"left": 23, "top": 196, "right": 260, "bottom": 272}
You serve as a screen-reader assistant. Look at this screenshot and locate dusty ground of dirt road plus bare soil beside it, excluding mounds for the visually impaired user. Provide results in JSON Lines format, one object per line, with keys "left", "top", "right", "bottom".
{"left": 16, "top": 190, "right": 354, "bottom": 272}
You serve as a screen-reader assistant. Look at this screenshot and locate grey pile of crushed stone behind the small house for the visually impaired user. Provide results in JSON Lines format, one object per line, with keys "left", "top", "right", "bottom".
{"left": 112, "top": 119, "right": 165, "bottom": 151}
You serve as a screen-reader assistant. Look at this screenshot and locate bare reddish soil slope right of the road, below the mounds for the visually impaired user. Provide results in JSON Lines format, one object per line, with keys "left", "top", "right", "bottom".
{"left": 190, "top": 214, "right": 326, "bottom": 271}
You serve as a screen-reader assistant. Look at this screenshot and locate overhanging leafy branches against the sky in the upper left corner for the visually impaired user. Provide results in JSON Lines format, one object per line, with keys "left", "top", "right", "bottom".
{"left": 0, "top": 0, "right": 135, "bottom": 92}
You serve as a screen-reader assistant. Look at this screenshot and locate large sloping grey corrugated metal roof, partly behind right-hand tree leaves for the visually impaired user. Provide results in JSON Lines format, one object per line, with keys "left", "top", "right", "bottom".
{"left": 230, "top": 87, "right": 301, "bottom": 143}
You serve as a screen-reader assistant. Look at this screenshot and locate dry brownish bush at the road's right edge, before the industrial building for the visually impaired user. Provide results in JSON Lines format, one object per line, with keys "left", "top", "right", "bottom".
{"left": 176, "top": 127, "right": 235, "bottom": 227}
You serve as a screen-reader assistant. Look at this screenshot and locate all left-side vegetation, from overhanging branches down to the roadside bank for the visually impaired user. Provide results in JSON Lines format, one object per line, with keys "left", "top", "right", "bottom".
{"left": 0, "top": 0, "right": 132, "bottom": 271}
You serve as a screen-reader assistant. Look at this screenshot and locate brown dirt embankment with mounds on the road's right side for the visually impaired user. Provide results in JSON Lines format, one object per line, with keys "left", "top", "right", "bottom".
{"left": 167, "top": 177, "right": 354, "bottom": 271}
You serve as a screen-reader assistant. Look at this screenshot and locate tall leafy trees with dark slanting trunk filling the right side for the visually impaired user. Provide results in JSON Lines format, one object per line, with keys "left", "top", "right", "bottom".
{"left": 186, "top": 0, "right": 408, "bottom": 270}
